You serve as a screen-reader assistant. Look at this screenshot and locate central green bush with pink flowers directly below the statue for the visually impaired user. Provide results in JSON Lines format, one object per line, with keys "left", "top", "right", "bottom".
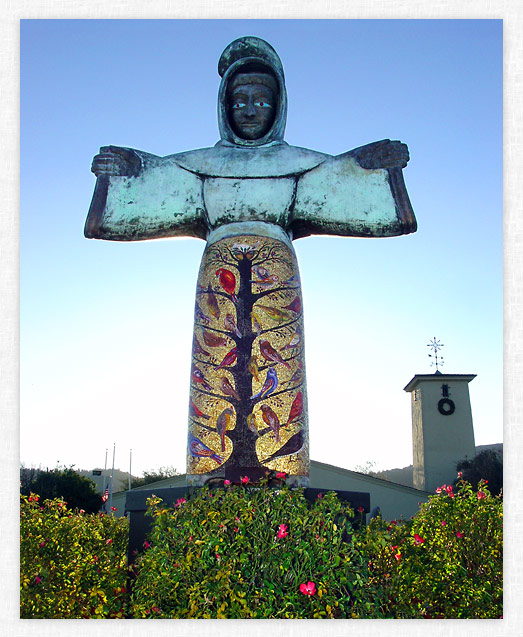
{"left": 128, "top": 481, "right": 379, "bottom": 618}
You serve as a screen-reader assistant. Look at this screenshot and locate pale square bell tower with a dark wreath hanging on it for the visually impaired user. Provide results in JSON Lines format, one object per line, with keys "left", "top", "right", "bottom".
{"left": 404, "top": 369, "right": 476, "bottom": 491}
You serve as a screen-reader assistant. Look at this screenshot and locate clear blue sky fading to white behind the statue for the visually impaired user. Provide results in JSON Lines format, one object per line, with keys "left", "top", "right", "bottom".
{"left": 20, "top": 20, "right": 503, "bottom": 474}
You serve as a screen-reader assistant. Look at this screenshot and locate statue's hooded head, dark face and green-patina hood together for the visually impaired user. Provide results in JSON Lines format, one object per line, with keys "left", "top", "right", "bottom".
{"left": 218, "top": 36, "right": 287, "bottom": 147}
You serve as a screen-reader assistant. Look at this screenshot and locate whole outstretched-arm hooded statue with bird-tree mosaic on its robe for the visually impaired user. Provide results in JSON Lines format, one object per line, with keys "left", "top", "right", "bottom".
{"left": 85, "top": 37, "right": 416, "bottom": 486}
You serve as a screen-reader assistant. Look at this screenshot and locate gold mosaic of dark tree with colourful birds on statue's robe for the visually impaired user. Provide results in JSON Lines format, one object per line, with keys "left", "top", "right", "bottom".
{"left": 188, "top": 236, "right": 308, "bottom": 477}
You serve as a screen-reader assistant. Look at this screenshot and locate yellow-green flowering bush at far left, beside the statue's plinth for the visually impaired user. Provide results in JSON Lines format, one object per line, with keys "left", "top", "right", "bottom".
{"left": 20, "top": 494, "right": 128, "bottom": 619}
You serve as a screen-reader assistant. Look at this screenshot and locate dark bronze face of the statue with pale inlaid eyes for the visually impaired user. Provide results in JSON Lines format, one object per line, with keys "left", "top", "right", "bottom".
{"left": 229, "top": 84, "right": 275, "bottom": 139}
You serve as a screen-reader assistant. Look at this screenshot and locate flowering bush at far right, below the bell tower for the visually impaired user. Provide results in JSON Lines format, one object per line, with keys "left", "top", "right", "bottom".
{"left": 358, "top": 479, "right": 503, "bottom": 619}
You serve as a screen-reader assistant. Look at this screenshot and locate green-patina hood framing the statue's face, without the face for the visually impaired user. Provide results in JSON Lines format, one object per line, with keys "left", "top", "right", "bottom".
{"left": 218, "top": 36, "right": 287, "bottom": 148}
